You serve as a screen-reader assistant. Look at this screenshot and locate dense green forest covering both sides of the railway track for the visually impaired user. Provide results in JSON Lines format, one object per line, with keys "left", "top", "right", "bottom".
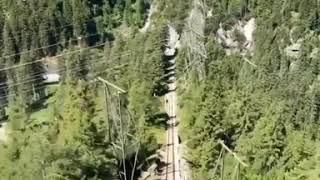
{"left": 0, "top": 0, "right": 320, "bottom": 180}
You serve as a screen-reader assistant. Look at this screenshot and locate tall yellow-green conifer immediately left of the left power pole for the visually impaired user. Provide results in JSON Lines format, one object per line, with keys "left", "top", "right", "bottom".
{"left": 54, "top": 79, "right": 117, "bottom": 179}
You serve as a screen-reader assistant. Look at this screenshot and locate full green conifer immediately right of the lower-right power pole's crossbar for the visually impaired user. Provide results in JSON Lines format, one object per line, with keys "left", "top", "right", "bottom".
{"left": 238, "top": 105, "right": 286, "bottom": 174}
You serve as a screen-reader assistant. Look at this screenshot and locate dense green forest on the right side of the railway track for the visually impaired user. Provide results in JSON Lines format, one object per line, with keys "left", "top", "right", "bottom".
{"left": 179, "top": 0, "right": 320, "bottom": 180}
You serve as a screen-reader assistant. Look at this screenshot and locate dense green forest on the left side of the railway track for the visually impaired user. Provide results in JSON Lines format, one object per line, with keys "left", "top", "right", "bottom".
{"left": 0, "top": 0, "right": 174, "bottom": 180}
